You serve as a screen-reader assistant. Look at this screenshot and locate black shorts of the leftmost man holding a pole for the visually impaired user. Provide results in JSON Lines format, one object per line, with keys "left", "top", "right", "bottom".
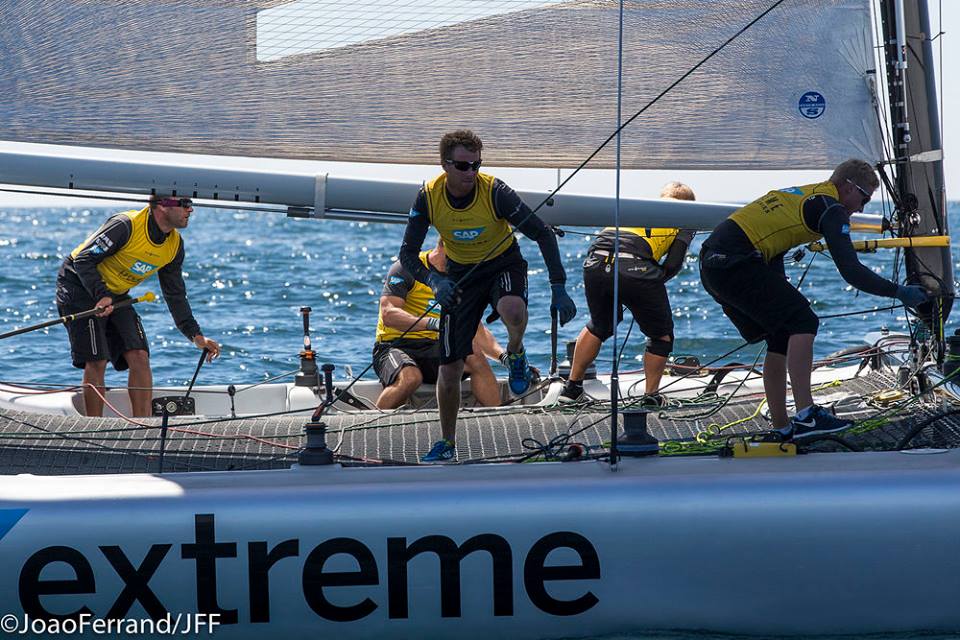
{"left": 57, "top": 278, "right": 150, "bottom": 371}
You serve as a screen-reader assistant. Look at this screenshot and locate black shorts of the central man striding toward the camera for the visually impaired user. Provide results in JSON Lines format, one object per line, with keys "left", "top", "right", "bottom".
{"left": 440, "top": 243, "right": 527, "bottom": 364}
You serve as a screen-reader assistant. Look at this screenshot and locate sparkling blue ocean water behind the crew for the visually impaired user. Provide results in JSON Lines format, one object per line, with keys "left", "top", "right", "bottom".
{"left": 0, "top": 202, "right": 960, "bottom": 386}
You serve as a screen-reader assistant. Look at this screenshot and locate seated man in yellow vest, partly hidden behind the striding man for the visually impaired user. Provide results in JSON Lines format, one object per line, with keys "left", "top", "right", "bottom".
{"left": 373, "top": 240, "right": 506, "bottom": 409}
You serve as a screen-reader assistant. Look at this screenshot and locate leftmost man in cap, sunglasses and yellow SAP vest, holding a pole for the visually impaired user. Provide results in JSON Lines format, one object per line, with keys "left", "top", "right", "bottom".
{"left": 57, "top": 196, "right": 220, "bottom": 416}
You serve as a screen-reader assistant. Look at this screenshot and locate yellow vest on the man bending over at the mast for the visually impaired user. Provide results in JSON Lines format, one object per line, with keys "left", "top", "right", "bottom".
{"left": 730, "top": 181, "right": 840, "bottom": 262}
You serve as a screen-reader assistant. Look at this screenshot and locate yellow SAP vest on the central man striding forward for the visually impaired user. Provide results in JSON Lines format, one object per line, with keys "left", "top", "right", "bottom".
{"left": 425, "top": 173, "right": 513, "bottom": 264}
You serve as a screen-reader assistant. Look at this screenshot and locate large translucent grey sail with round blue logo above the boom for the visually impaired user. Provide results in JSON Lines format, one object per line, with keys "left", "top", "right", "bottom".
{"left": 0, "top": 0, "right": 882, "bottom": 170}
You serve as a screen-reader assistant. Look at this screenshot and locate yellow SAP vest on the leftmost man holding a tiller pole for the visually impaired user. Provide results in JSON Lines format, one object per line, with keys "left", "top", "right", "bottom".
{"left": 70, "top": 207, "right": 180, "bottom": 294}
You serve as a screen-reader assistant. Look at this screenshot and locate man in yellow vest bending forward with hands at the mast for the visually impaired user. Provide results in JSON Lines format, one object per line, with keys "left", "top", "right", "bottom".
{"left": 700, "top": 160, "right": 927, "bottom": 439}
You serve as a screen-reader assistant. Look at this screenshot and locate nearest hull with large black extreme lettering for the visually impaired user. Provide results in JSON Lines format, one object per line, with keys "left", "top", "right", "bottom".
{"left": 0, "top": 450, "right": 960, "bottom": 639}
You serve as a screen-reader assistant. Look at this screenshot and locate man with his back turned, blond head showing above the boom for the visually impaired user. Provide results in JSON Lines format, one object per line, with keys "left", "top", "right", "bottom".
{"left": 559, "top": 182, "right": 695, "bottom": 407}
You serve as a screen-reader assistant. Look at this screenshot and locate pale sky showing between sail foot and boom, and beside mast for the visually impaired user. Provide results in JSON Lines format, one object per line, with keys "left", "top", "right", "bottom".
{"left": 0, "top": 0, "right": 960, "bottom": 207}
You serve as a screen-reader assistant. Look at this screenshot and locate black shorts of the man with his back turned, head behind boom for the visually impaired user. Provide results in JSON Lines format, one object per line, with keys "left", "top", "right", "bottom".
{"left": 583, "top": 253, "right": 673, "bottom": 341}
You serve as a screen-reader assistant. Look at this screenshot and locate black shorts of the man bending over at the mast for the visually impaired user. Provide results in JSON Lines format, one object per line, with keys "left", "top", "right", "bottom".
{"left": 700, "top": 248, "right": 819, "bottom": 354}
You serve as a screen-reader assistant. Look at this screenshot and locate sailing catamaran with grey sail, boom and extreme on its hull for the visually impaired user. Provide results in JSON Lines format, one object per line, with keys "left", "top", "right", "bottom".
{"left": 0, "top": 0, "right": 960, "bottom": 638}
